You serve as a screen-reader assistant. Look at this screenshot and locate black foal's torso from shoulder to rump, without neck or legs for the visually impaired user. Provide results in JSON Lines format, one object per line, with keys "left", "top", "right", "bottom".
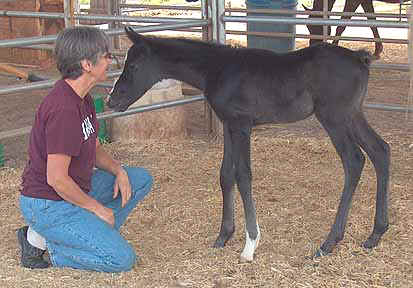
{"left": 197, "top": 44, "right": 370, "bottom": 125}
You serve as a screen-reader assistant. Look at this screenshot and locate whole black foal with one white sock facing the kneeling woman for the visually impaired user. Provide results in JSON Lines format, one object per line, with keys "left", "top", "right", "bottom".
{"left": 108, "top": 28, "right": 390, "bottom": 261}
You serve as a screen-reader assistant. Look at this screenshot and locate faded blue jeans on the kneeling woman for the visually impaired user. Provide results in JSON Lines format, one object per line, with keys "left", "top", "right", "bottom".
{"left": 20, "top": 167, "right": 152, "bottom": 272}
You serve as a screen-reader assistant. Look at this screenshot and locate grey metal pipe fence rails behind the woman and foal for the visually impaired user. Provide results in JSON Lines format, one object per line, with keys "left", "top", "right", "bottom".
{"left": 0, "top": 0, "right": 413, "bottom": 140}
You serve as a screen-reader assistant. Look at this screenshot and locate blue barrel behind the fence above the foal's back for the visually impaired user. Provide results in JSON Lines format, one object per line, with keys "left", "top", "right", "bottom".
{"left": 246, "top": 0, "right": 297, "bottom": 53}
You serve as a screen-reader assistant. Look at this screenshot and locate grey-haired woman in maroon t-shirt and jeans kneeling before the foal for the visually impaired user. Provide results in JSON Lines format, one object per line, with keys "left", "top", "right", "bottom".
{"left": 17, "top": 27, "right": 152, "bottom": 272}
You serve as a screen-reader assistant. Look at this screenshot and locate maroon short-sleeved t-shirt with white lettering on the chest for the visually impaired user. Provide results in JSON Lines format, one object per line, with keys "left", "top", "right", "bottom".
{"left": 22, "top": 80, "right": 98, "bottom": 200}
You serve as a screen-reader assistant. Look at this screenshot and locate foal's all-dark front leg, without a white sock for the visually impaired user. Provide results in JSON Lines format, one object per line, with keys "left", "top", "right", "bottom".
{"left": 214, "top": 122, "right": 235, "bottom": 248}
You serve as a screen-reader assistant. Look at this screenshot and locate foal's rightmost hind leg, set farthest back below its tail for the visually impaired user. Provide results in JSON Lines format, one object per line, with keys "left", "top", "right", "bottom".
{"left": 354, "top": 112, "right": 390, "bottom": 248}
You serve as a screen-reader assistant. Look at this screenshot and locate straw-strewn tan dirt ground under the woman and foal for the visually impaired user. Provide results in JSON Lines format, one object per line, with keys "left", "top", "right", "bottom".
{"left": 0, "top": 34, "right": 413, "bottom": 288}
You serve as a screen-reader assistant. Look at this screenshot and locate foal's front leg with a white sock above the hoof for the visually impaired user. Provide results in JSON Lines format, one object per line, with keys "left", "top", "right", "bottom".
{"left": 229, "top": 119, "right": 260, "bottom": 262}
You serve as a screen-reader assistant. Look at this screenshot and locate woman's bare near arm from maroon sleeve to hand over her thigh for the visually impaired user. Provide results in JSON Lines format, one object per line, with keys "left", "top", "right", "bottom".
{"left": 47, "top": 154, "right": 115, "bottom": 226}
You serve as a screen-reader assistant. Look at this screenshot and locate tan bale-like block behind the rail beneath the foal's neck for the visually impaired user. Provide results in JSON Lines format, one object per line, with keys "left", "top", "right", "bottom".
{"left": 109, "top": 79, "right": 186, "bottom": 141}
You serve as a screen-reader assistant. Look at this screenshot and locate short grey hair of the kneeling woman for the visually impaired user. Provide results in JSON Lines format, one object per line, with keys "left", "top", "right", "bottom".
{"left": 54, "top": 26, "right": 109, "bottom": 79}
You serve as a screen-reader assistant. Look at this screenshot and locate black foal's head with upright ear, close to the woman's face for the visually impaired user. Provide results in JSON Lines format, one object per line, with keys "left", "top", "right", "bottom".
{"left": 108, "top": 27, "right": 161, "bottom": 111}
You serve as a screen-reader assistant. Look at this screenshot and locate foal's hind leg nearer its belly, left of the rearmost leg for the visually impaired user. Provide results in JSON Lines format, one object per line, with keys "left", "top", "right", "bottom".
{"left": 314, "top": 115, "right": 365, "bottom": 257}
